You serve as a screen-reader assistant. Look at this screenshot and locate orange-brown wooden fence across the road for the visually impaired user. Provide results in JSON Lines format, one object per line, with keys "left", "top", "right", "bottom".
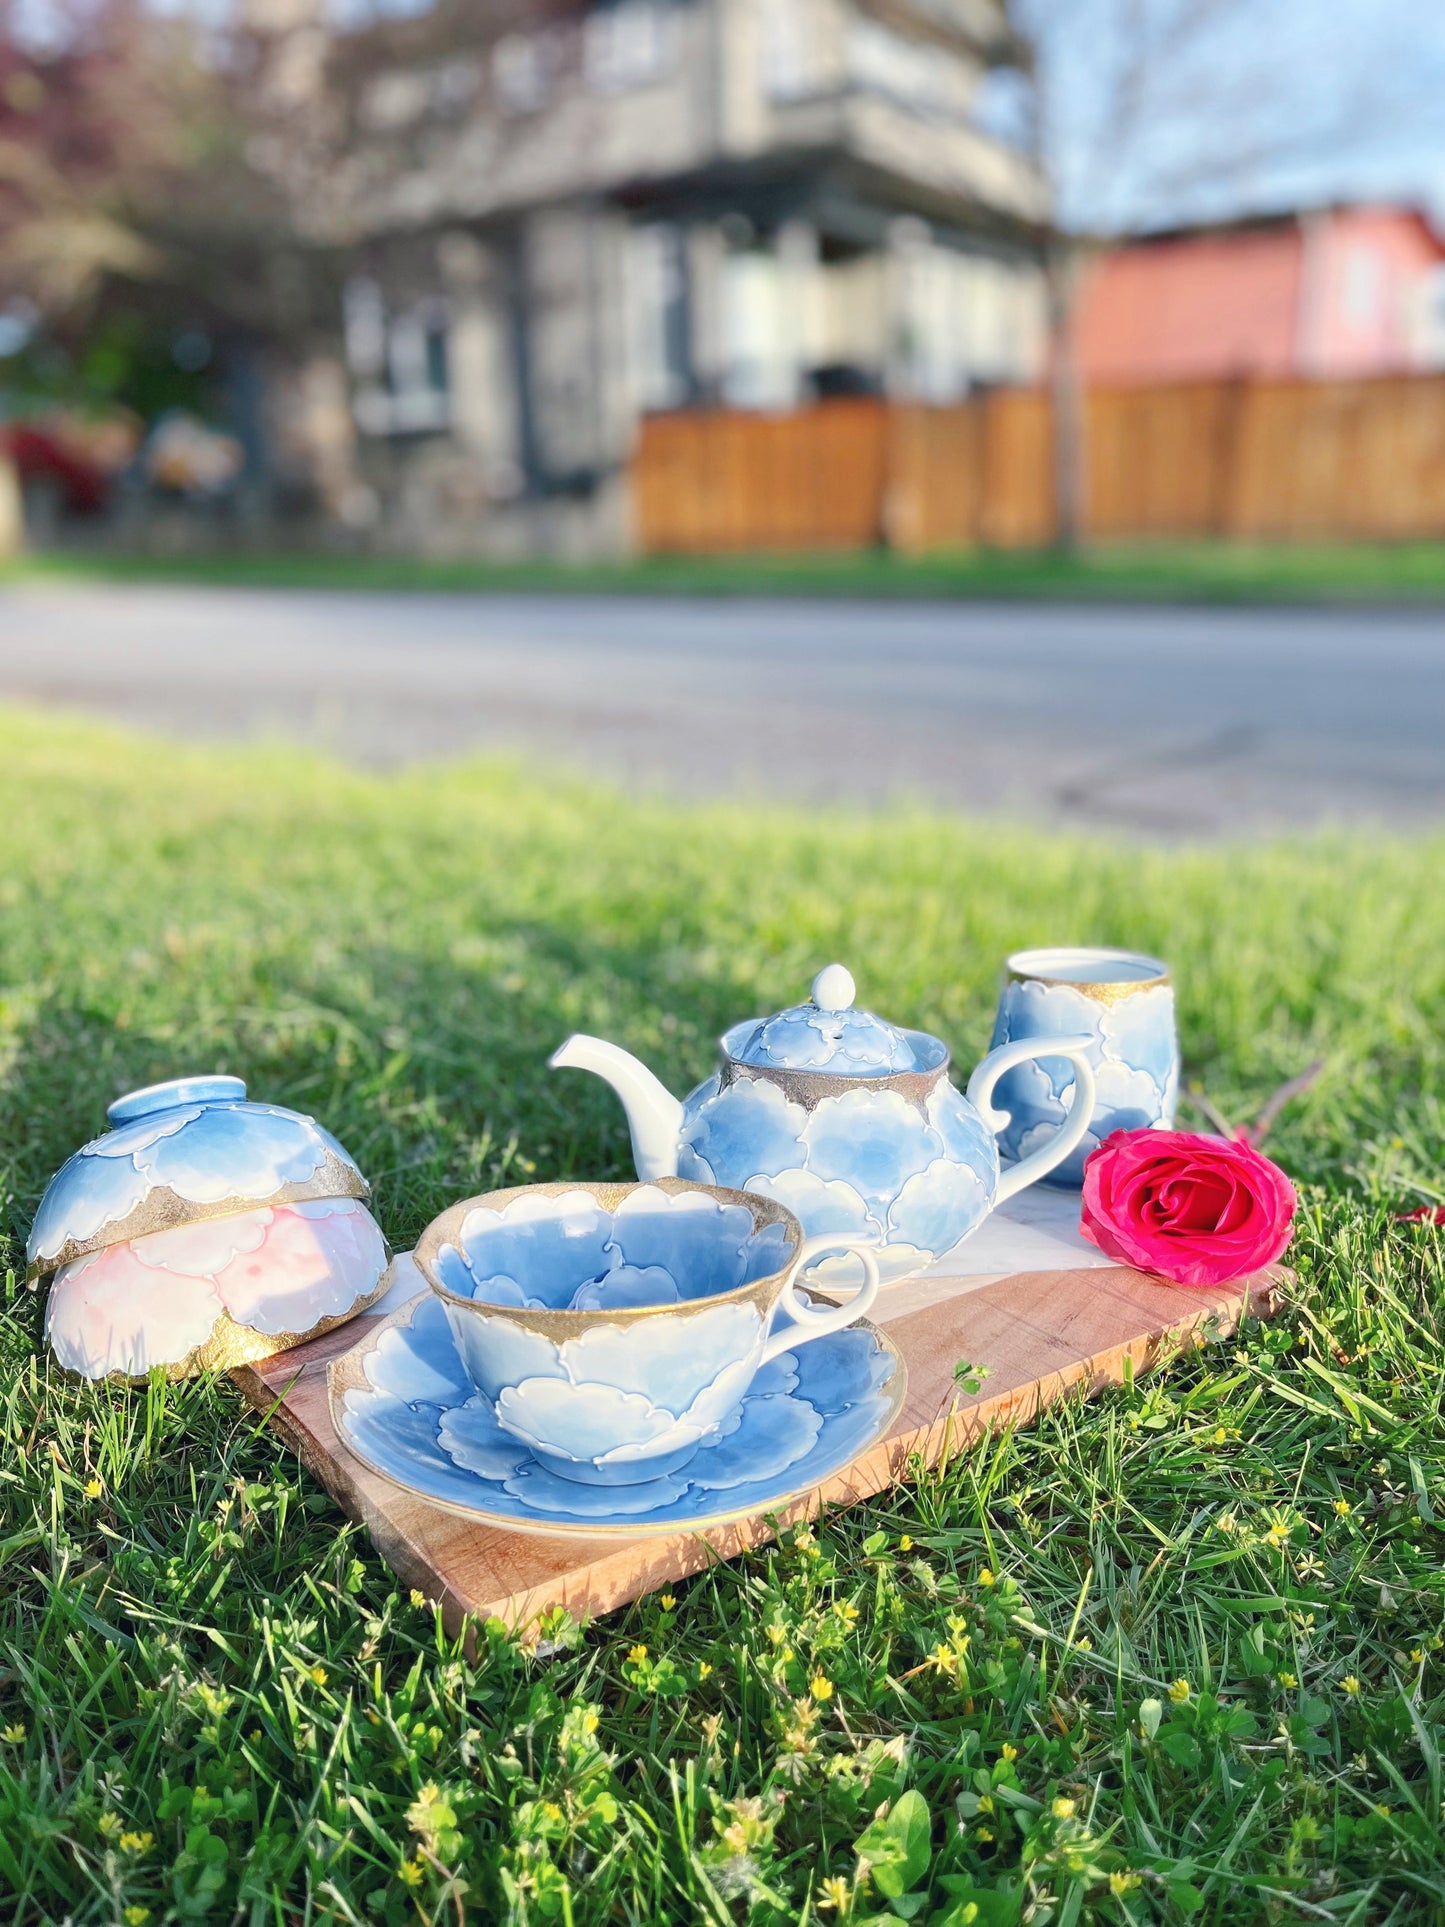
{"left": 634, "top": 376, "right": 1445, "bottom": 555}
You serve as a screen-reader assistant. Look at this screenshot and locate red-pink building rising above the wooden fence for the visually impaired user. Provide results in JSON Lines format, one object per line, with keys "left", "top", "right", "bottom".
{"left": 1075, "top": 206, "right": 1445, "bottom": 387}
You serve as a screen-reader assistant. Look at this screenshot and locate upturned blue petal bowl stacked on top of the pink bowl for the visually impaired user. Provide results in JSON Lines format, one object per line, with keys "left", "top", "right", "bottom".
{"left": 25, "top": 1075, "right": 370, "bottom": 1280}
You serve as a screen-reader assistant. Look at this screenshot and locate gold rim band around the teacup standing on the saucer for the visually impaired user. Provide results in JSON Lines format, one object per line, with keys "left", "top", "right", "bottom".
{"left": 412, "top": 1177, "right": 803, "bottom": 1345}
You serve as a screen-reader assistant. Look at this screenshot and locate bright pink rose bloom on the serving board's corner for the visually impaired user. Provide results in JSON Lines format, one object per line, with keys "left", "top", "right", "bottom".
{"left": 1079, "top": 1131, "right": 1295, "bottom": 1285}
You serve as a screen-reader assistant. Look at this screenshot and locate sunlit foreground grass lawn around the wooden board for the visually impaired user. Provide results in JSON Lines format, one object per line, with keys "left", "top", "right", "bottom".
{"left": 0, "top": 711, "right": 1445, "bottom": 1927}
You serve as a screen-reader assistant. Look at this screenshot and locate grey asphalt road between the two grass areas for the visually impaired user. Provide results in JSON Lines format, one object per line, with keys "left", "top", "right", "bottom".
{"left": 0, "top": 584, "right": 1445, "bottom": 836}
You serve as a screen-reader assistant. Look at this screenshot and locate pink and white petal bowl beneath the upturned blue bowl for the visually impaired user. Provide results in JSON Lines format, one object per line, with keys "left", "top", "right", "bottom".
{"left": 46, "top": 1199, "right": 387, "bottom": 1378}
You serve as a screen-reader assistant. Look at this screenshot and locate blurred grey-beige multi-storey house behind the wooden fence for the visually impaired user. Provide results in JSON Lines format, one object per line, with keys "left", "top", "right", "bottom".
{"left": 252, "top": 0, "right": 1046, "bottom": 553}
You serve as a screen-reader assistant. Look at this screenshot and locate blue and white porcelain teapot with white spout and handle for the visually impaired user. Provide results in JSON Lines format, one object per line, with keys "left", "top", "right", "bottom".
{"left": 551, "top": 964, "right": 1094, "bottom": 1281}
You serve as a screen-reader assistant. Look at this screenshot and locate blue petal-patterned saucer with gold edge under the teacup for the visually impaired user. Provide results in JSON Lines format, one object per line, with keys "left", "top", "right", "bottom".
{"left": 328, "top": 1293, "right": 907, "bottom": 1538}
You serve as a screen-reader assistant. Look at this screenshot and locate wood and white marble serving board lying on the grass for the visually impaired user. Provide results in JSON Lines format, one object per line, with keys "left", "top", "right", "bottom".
{"left": 231, "top": 1193, "right": 1279, "bottom": 1632}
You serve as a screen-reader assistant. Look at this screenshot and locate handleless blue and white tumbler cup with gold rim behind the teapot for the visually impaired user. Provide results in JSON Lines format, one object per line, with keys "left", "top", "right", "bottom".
{"left": 992, "top": 948, "right": 1179, "bottom": 1185}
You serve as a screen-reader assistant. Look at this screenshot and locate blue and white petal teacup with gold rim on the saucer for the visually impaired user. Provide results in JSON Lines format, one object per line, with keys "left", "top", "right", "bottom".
{"left": 416, "top": 1177, "right": 879, "bottom": 1486}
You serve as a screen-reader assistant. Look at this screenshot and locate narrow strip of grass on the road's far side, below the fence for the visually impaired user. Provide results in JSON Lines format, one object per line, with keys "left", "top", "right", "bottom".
{"left": 0, "top": 541, "right": 1445, "bottom": 603}
